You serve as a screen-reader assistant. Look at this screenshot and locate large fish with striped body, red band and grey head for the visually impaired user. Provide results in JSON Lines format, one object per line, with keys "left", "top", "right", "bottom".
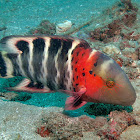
{"left": 0, "top": 35, "right": 136, "bottom": 110}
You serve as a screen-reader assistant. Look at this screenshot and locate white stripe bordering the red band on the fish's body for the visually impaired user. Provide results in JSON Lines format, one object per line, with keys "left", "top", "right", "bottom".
{"left": 66, "top": 40, "right": 80, "bottom": 90}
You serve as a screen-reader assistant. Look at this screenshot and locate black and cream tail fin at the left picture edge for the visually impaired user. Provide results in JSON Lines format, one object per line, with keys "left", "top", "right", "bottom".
{"left": 0, "top": 51, "right": 14, "bottom": 78}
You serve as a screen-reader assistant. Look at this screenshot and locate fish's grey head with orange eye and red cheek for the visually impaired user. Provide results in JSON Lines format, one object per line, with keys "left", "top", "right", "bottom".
{"left": 87, "top": 52, "right": 136, "bottom": 106}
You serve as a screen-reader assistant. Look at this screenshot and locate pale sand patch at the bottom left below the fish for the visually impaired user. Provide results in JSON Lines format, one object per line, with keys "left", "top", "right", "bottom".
{"left": 0, "top": 99, "right": 63, "bottom": 140}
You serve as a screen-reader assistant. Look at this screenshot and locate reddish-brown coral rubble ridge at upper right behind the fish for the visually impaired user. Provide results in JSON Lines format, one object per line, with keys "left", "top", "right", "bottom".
{"left": 89, "top": 13, "right": 139, "bottom": 43}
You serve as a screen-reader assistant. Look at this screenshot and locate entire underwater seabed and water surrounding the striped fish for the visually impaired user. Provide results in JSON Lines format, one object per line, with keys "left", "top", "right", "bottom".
{"left": 0, "top": 0, "right": 140, "bottom": 140}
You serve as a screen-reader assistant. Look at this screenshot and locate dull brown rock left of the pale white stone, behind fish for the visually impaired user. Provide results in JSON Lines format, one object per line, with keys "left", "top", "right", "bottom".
{"left": 27, "top": 20, "right": 56, "bottom": 35}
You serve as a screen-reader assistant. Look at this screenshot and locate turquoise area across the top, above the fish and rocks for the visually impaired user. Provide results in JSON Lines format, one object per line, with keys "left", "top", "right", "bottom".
{"left": 0, "top": 0, "right": 122, "bottom": 37}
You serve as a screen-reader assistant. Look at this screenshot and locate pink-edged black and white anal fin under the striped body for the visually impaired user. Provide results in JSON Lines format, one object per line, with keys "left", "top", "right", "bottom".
{"left": 8, "top": 79, "right": 52, "bottom": 93}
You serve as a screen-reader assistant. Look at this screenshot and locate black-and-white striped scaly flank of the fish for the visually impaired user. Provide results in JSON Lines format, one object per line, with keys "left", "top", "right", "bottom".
{"left": 0, "top": 37, "right": 85, "bottom": 90}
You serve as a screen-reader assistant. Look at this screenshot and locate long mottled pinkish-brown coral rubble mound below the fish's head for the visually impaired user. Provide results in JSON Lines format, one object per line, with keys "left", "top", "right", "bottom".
{"left": 37, "top": 111, "right": 138, "bottom": 140}
